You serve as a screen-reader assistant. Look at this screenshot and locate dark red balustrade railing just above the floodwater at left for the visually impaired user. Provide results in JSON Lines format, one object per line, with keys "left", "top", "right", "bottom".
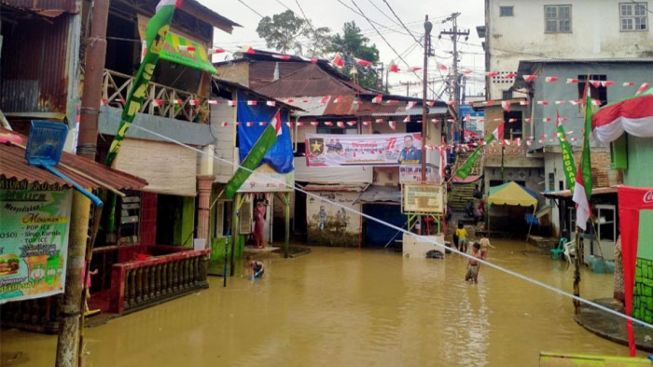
{"left": 110, "top": 249, "right": 210, "bottom": 313}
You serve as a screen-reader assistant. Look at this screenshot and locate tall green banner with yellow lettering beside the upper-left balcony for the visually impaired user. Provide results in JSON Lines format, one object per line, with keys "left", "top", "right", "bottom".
{"left": 106, "top": 0, "right": 178, "bottom": 166}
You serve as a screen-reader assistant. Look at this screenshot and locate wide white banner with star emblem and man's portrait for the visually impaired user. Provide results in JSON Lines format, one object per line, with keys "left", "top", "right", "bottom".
{"left": 305, "top": 133, "right": 422, "bottom": 167}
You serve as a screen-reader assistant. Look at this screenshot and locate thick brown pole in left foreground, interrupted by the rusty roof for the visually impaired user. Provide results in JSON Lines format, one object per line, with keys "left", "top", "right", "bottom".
{"left": 56, "top": 0, "right": 109, "bottom": 367}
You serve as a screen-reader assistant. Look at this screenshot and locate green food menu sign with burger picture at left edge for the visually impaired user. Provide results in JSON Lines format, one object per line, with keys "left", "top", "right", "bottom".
{"left": 0, "top": 180, "right": 72, "bottom": 304}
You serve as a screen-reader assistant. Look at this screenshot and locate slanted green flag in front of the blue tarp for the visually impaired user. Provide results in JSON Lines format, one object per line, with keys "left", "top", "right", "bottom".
{"left": 224, "top": 110, "right": 282, "bottom": 199}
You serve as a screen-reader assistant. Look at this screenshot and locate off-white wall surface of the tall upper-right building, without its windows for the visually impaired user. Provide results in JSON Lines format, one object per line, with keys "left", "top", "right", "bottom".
{"left": 486, "top": 0, "right": 653, "bottom": 99}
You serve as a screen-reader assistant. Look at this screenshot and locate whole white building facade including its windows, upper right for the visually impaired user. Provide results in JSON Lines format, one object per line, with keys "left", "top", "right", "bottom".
{"left": 485, "top": 0, "right": 653, "bottom": 100}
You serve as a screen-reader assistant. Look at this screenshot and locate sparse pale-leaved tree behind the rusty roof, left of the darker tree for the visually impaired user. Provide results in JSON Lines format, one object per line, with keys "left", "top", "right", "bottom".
{"left": 256, "top": 10, "right": 331, "bottom": 57}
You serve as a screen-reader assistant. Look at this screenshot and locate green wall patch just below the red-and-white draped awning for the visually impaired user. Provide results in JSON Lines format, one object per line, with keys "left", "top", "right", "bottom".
{"left": 624, "top": 135, "right": 653, "bottom": 188}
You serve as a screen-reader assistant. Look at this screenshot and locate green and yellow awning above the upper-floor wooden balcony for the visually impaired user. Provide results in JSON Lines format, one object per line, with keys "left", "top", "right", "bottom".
{"left": 138, "top": 14, "right": 217, "bottom": 74}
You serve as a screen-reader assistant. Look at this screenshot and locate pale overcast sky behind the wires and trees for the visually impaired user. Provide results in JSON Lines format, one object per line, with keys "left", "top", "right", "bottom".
{"left": 200, "top": 0, "right": 484, "bottom": 99}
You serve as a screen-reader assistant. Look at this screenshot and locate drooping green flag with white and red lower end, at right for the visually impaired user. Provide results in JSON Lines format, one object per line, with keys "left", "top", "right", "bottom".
{"left": 573, "top": 88, "right": 592, "bottom": 231}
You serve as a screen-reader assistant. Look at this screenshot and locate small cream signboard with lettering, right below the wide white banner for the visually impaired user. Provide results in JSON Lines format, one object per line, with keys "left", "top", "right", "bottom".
{"left": 401, "top": 184, "right": 444, "bottom": 214}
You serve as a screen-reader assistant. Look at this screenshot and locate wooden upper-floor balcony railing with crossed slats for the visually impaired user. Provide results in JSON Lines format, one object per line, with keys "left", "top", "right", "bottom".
{"left": 102, "top": 69, "right": 209, "bottom": 123}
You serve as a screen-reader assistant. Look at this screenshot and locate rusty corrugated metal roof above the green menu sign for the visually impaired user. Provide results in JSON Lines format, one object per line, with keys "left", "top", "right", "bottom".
{"left": 0, "top": 129, "right": 147, "bottom": 190}
